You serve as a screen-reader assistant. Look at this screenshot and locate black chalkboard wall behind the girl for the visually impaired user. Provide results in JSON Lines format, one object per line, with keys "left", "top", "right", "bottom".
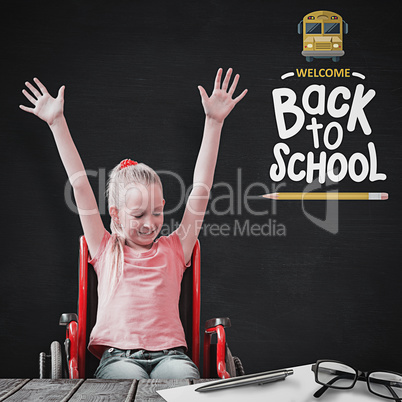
{"left": 0, "top": 0, "right": 402, "bottom": 377}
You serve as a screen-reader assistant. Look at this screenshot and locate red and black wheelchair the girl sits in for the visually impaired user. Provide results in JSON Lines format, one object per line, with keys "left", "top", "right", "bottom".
{"left": 39, "top": 236, "right": 245, "bottom": 379}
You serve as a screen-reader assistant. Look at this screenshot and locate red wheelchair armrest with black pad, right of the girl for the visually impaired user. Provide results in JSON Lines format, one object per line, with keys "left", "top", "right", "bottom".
{"left": 203, "top": 317, "right": 231, "bottom": 378}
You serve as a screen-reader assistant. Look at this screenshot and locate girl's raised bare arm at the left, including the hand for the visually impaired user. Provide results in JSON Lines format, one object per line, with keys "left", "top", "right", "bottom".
{"left": 20, "top": 78, "right": 104, "bottom": 256}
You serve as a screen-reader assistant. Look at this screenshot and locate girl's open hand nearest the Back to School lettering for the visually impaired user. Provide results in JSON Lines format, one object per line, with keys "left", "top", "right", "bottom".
{"left": 198, "top": 68, "right": 247, "bottom": 123}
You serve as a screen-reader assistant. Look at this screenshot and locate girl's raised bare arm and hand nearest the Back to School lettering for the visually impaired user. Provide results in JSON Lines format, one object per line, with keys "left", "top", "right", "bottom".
{"left": 177, "top": 68, "right": 247, "bottom": 262}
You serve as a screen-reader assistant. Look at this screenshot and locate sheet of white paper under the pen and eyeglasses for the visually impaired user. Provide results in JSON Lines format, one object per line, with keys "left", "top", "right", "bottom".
{"left": 157, "top": 364, "right": 384, "bottom": 402}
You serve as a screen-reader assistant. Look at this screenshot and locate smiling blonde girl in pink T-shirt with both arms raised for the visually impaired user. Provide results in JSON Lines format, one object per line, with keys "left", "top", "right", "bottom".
{"left": 20, "top": 69, "right": 247, "bottom": 379}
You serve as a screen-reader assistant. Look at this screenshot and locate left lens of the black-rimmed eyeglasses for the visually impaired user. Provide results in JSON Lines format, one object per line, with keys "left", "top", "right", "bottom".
{"left": 317, "top": 362, "right": 357, "bottom": 388}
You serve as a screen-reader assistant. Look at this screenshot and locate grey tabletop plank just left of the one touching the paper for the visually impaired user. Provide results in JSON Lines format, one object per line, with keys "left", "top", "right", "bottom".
{"left": 68, "top": 378, "right": 137, "bottom": 402}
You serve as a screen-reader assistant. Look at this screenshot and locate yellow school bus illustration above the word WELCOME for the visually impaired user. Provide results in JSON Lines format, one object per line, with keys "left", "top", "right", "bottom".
{"left": 297, "top": 11, "right": 348, "bottom": 61}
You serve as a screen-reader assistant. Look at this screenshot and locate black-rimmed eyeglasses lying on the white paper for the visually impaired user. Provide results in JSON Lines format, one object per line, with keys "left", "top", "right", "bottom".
{"left": 311, "top": 360, "right": 402, "bottom": 401}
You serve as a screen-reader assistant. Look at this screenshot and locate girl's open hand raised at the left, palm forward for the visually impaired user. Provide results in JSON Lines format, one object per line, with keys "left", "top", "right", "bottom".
{"left": 20, "top": 78, "right": 65, "bottom": 126}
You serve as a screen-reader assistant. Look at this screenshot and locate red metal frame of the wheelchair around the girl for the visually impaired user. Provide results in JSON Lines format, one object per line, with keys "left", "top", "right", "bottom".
{"left": 53, "top": 236, "right": 244, "bottom": 379}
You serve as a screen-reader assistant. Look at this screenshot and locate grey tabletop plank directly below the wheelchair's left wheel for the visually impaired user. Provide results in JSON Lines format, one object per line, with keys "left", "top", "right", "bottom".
{"left": 2, "top": 379, "right": 82, "bottom": 402}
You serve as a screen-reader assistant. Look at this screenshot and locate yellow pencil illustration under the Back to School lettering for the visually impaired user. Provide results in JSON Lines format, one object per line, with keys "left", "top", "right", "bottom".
{"left": 262, "top": 192, "right": 388, "bottom": 201}
